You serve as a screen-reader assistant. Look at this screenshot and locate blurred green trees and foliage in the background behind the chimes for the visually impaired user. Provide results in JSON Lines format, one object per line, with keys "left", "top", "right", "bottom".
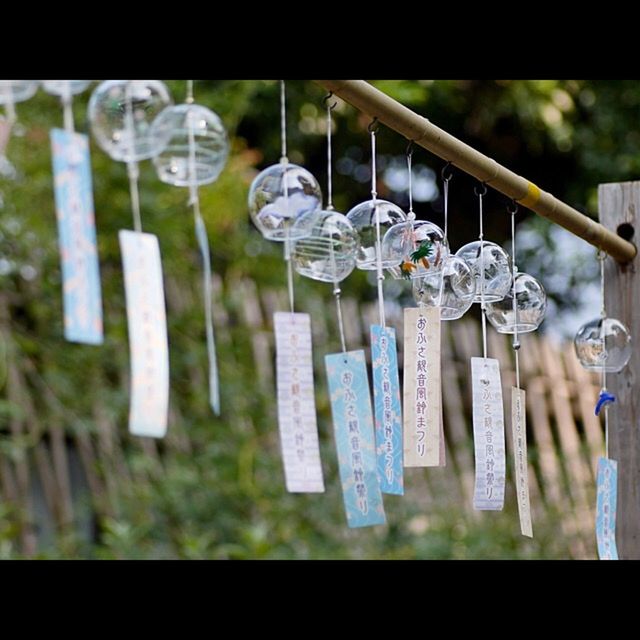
{"left": 0, "top": 80, "right": 640, "bottom": 558}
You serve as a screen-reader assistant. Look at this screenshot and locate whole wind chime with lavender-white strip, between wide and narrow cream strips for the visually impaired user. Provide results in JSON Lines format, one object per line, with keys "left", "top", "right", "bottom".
{"left": 464, "top": 183, "right": 512, "bottom": 511}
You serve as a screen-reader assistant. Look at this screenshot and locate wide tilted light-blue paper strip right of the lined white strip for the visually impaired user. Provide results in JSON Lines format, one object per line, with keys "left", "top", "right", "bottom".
{"left": 325, "top": 350, "right": 385, "bottom": 527}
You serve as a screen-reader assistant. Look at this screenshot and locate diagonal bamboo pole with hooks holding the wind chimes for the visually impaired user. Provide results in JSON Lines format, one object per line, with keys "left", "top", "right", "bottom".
{"left": 314, "top": 80, "right": 636, "bottom": 263}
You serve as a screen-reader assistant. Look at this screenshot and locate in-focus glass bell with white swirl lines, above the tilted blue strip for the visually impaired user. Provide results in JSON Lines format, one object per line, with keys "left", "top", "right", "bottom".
{"left": 291, "top": 210, "right": 359, "bottom": 282}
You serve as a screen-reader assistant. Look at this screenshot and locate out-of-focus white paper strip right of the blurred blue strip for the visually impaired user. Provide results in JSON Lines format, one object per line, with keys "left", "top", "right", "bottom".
{"left": 118, "top": 230, "right": 169, "bottom": 438}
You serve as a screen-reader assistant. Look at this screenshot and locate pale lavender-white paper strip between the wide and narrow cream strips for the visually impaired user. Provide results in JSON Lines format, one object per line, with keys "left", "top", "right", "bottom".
{"left": 471, "top": 358, "right": 506, "bottom": 511}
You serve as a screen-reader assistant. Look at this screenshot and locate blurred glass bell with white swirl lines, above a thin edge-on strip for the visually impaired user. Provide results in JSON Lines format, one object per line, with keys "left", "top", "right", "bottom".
{"left": 150, "top": 104, "right": 229, "bottom": 187}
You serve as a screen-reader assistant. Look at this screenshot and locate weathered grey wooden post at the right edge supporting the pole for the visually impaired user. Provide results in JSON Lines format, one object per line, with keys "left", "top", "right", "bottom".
{"left": 598, "top": 182, "right": 640, "bottom": 560}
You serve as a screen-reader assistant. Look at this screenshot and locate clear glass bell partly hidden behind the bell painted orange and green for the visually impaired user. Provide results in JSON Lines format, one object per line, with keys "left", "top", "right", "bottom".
{"left": 412, "top": 255, "right": 476, "bottom": 320}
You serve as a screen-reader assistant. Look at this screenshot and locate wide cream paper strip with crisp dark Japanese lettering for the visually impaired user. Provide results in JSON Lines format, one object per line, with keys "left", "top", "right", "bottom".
{"left": 403, "top": 307, "right": 442, "bottom": 467}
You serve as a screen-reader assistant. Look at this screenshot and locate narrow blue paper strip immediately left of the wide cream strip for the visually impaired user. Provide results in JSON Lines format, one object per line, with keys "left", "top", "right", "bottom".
{"left": 371, "top": 324, "right": 404, "bottom": 496}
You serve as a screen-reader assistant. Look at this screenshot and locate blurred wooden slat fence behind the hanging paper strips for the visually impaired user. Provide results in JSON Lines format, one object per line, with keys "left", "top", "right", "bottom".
{"left": 0, "top": 278, "right": 604, "bottom": 558}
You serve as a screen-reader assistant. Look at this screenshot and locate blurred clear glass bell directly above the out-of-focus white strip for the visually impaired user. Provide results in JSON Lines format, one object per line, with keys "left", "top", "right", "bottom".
{"left": 88, "top": 80, "right": 172, "bottom": 162}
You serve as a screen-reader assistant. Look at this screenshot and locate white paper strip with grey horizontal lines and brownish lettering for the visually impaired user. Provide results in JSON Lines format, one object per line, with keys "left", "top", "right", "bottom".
{"left": 273, "top": 312, "right": 324, "bottom": 493}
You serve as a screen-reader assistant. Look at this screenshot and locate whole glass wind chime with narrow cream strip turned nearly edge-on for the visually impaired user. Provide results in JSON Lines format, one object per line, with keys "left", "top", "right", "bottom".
{"left": 486, "top": 202, "right": 547, "bottom": 538}
